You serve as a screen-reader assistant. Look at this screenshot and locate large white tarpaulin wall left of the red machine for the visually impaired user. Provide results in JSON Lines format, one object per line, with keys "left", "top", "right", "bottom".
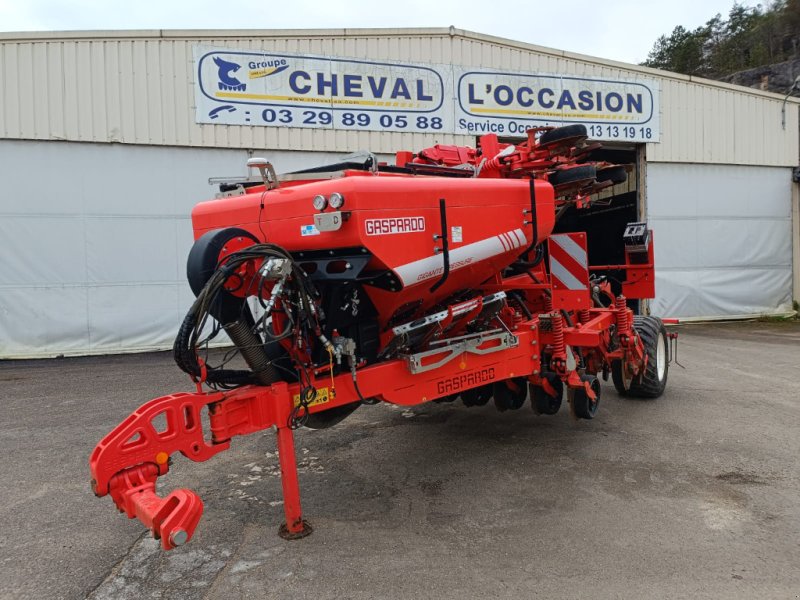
{"left": 0, "top": 140, "right": 340, "bottom": 358}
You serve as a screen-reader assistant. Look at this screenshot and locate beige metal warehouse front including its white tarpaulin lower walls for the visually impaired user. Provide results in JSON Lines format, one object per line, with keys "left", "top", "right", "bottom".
{"left": 0, "top": 28, "right": 800, "bottom": 356}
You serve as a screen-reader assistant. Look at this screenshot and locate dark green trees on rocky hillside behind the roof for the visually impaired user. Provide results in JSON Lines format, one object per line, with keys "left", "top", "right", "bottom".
{"left": 642, "top": 0, "right": 800, "bottom": 78}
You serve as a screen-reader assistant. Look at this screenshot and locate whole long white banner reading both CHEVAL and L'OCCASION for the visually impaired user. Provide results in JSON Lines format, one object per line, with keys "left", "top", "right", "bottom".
{"left": 194, "top": 46, "right": 661, "bottom": 142}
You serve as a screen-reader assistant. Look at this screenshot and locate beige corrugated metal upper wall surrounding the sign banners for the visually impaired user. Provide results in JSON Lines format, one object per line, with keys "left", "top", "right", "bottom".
{"left": 0, "top": 29, "right": 798, "bottom": 166}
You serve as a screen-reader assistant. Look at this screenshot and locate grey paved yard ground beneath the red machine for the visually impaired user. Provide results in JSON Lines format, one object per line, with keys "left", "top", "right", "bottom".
{"left": 0, "top": 323, "right": 800, "bottom": 599}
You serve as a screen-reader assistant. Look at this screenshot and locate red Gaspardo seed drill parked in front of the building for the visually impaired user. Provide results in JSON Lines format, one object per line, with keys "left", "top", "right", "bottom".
{"left": 89, "top": 125, "right": 669, "bottom": 550}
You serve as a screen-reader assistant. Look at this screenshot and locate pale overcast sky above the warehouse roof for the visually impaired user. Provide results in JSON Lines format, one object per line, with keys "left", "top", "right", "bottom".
{"left": 0, "top": 0, "right": 757, "bottom": 63}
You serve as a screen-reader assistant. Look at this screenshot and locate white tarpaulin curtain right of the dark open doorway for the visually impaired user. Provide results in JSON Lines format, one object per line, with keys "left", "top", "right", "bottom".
{"left": 647, "top": 163, "right": 792, "bottom": 317}
